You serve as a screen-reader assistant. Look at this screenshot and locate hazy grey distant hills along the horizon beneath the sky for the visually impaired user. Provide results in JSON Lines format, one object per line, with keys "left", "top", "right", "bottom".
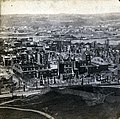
{"left": 1, "top": 13, "right": 120, "bottom": 27}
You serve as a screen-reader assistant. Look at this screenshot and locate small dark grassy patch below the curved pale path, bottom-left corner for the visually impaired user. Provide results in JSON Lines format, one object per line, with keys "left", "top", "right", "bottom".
{"left": 0, "top": 109, "right": 46, "bottom": 119}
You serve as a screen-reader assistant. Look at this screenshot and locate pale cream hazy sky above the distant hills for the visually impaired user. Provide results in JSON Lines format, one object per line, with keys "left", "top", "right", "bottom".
{"left": 1, "top": 0, "right": 120, "bottom": 14}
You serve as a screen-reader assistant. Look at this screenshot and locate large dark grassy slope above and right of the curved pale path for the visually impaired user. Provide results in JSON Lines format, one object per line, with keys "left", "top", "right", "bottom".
{"left": 5, "top": 92, "right": 120, "bottom": 119}
